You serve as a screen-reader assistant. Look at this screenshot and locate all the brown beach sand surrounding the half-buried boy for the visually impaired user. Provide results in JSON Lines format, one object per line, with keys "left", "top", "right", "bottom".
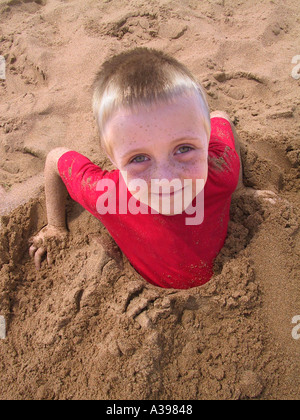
{"left": 0, "top": 0, "right": 300, "bottom": 400}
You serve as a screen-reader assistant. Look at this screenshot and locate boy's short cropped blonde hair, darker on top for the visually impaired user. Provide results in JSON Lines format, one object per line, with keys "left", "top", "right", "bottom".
{"left": 93, "top": 48, "right": 211, "bottom": 155}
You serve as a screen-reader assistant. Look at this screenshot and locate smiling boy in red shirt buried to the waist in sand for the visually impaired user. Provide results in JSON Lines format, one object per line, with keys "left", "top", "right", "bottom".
{"left": 30, "top": 48, "right": 241, "bottom": 289}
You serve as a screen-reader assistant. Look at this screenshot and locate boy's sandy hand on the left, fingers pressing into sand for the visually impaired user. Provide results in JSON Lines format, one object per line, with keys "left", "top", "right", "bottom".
{"left": 29, "top": 225, "right": 68, "bottom": 270}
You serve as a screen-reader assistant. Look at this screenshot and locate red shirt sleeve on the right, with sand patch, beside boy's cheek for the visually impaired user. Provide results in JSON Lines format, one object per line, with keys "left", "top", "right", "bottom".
{"left": 208, "top": 117, "right": 241, "bottom": 193}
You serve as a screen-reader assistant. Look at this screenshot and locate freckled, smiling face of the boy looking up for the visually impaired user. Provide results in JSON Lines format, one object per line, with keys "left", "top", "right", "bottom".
{"left": 104, "top": 96, "right": 209, "bottom": 215}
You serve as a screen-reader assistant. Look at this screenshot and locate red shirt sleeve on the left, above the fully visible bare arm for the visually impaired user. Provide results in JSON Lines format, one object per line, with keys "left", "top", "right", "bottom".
{"left": 58, "top": 151, "right": 119, "bottom": 215}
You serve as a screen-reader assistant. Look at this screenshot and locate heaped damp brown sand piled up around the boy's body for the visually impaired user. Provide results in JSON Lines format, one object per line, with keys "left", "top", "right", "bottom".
{"left": 0, "top": 186, "right": 299, "bottom": 399}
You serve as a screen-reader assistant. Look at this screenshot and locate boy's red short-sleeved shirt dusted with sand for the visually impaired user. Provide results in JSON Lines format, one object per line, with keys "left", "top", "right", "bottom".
{"left": 58, "top": 118, "right": 240, "bottom": 289}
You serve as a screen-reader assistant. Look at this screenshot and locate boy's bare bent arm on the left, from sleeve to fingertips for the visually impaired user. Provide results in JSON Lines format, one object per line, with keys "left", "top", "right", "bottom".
{"left": 29, "top": 147, "right": 69, "bottom": 270}
